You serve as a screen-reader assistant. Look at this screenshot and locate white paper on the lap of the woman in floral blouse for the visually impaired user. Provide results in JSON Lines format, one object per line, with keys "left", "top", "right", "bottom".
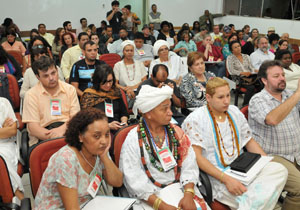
{"left": 82, "top": 196, "right": 136, "bottom": 210}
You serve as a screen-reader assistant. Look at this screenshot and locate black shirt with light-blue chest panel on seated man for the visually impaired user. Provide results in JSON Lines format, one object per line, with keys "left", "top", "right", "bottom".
{"left": 70, "top": 59, "right": 105, "bottom": 91}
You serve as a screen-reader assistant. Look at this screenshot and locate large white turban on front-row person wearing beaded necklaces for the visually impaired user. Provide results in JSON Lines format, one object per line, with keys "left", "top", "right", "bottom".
{"left": 133, "top": 85, "right": 173, "bottom": 115}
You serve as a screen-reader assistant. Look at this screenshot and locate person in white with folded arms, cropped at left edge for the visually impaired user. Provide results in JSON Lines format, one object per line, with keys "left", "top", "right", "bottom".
{"left": 0, "top": 97, "right": 24, "bottom": 200}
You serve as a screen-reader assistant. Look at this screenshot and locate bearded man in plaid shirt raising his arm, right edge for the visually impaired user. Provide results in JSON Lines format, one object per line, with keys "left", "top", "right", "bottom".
{"left": 249, "top": 60, "right": 300, "bottom": 209}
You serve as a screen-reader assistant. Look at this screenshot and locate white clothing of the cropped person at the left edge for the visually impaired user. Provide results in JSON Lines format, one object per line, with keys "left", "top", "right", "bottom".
{"left": 0, "top": 97, "right": 24, "bottom": 192}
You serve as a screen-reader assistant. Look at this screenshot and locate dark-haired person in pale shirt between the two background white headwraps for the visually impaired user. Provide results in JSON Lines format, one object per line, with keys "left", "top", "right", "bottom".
{"left": 133, "top": 32, "right": 154, "bottom": 67}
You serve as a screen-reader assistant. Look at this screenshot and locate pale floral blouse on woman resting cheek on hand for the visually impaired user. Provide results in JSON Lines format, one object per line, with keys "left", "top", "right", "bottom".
{"left": 34, "top": 145, "right": 104, "bottom": 210}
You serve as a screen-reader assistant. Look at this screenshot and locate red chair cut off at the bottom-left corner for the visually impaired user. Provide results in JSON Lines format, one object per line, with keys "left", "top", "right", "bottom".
{"left": 0, "top": 155, "right": 31, "bottom": 210}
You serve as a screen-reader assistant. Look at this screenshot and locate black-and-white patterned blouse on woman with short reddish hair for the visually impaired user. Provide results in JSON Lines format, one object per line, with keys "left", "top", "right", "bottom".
{"left": 179, "top": 72, "right": 215, "bottom": 108}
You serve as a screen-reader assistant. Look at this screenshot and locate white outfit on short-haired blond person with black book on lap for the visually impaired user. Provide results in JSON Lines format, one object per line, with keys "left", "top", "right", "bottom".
{"left": 182, "top": 105, "right": 287, "bottom": 210}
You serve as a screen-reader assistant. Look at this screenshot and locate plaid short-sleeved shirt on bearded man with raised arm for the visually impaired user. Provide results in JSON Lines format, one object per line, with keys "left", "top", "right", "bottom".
{"left": 249, "top": 89, "right": 300, "bottom": 165}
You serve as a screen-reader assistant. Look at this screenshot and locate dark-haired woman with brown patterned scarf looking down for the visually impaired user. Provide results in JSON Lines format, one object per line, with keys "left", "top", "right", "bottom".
{"left": 80, "top": 64, "right": 129, "bottom": 133}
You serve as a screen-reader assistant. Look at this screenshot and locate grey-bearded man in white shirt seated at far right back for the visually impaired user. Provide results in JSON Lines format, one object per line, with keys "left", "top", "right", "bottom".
{"left": 250, "top": 36, "right": 275, "bottom": 69}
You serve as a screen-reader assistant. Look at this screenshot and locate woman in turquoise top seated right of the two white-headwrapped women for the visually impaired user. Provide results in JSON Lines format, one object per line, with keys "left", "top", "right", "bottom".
{"left": 173, "top": 32, "right": 197, "bottom": 57}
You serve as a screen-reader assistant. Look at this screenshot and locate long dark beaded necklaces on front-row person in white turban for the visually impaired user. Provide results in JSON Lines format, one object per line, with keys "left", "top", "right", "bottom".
{"left": 137, "top": 118, "right": 182, "bottom": 188}
